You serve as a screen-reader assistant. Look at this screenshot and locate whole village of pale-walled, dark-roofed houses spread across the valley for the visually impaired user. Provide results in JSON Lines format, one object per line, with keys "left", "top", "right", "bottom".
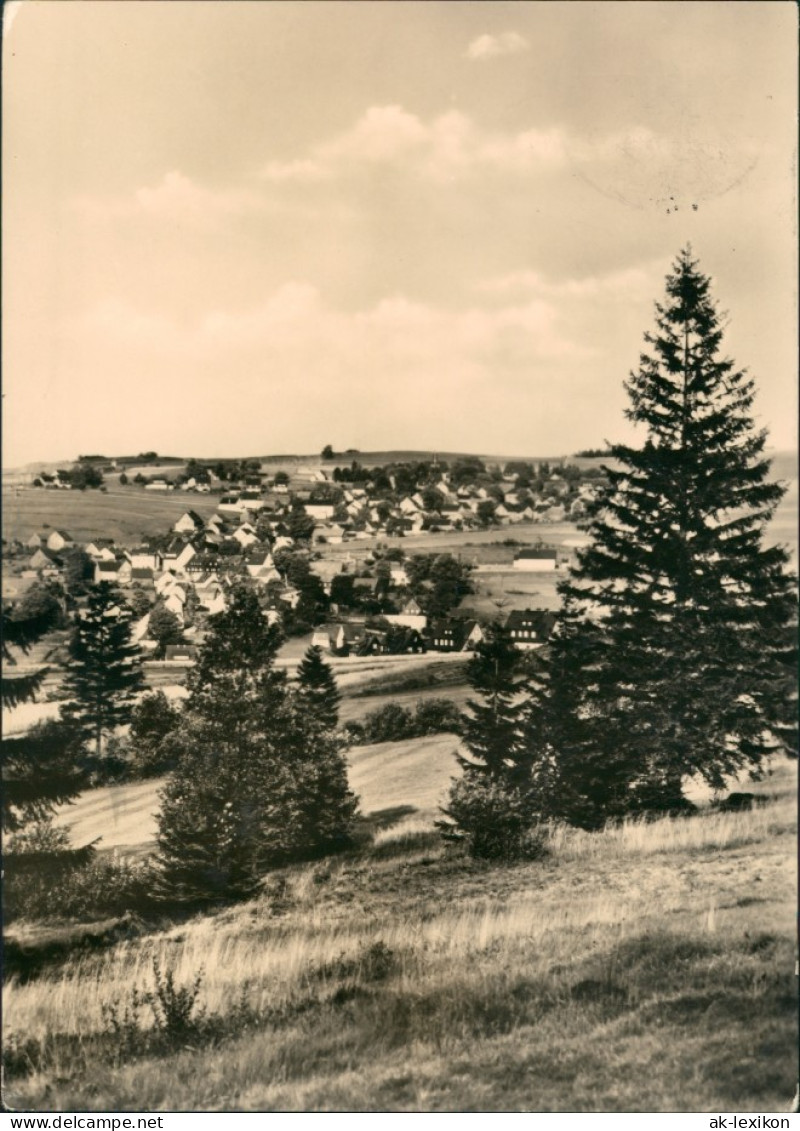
{"left": 7, "top": 454, "right": 595, "bottom": 659}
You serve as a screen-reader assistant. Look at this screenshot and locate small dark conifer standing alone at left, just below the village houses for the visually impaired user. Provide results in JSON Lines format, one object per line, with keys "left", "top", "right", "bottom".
{"left": 62, "top": 581, "right": 144, "bottom": 759}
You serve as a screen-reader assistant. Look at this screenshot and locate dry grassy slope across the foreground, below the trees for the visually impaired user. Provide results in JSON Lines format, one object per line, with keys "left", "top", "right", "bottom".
{"left": 5, "top": 766, "right": 798, "bottom": 1112}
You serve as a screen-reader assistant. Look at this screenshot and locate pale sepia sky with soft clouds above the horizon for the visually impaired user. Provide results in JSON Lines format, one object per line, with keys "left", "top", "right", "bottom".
{"left": 2, "top": 0, "right": 798, "bottom": 467}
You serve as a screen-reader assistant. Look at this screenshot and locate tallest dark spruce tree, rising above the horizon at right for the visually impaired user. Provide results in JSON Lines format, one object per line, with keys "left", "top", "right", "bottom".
{"left": 549, "top": 249, "right": 795, "bottom": 826}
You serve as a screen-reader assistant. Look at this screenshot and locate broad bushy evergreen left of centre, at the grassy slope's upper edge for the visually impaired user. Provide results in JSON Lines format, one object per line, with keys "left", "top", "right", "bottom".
{"left": 158, "top": 588, "right": 356, "bottom": 903}
